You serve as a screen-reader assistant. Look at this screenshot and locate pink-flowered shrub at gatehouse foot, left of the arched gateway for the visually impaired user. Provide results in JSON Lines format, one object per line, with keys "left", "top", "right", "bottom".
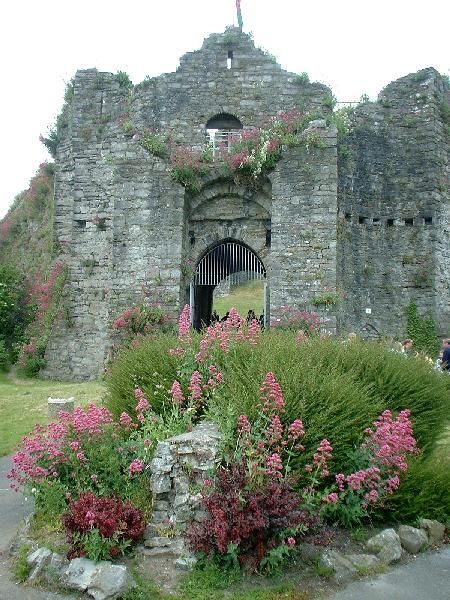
{"left": 113, "top": 302, "right": 172, "bottom": 342}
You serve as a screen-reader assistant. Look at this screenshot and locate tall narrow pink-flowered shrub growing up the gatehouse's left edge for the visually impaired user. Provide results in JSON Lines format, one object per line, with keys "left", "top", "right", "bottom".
{"left": 17, "top": 261, "right": 67, "bottom": 377}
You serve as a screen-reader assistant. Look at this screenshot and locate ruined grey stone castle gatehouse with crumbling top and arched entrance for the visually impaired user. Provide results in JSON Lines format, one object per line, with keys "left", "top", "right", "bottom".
{"left": 45, "top": 28, "right": 450, "bottom": 379}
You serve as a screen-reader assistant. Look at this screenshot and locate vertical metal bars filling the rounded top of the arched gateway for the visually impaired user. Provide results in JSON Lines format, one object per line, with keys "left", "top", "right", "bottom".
{"left": 193, "top": 242, "right": 266, "bottom": 285}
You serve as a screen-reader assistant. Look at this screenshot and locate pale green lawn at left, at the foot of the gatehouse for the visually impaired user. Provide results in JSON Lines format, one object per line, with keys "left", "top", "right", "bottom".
{"left": 0, "top": 373, "right": 105, "bottom": 456}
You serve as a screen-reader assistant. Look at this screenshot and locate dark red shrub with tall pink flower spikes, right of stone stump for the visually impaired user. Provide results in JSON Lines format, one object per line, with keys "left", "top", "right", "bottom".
{"left": 188, "top": 373, "right": 311, "bottom": 567}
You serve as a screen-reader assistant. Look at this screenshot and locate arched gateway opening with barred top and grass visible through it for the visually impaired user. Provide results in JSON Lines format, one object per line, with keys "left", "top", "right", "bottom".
{"left": 190, "top": 240, "right": 269, "bottom": 329}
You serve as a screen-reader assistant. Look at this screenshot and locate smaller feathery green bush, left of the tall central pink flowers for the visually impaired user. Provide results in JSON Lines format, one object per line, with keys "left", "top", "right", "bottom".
{"left": 106, "top": 334, "right": 179, "bottom": 418}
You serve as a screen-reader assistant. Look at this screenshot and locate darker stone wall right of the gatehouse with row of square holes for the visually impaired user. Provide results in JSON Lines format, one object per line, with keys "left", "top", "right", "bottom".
{"left": 338, "top": 69, "right": 450, "bottom": 335}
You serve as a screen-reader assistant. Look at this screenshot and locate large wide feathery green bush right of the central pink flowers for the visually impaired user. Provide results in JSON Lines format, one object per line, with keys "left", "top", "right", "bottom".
{"left": 209, "top": 331, "right": 450, "bottom": 471}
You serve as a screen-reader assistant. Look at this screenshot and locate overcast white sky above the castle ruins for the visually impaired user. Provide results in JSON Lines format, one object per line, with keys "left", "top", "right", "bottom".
{"left": 0, "top": 0, "right": 450, "bottom": 218}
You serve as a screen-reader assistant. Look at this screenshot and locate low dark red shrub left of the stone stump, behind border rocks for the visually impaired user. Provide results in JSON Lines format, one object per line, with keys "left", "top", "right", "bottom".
{"left": 62, "top": 492, "right": 145, "bottom": 561}
